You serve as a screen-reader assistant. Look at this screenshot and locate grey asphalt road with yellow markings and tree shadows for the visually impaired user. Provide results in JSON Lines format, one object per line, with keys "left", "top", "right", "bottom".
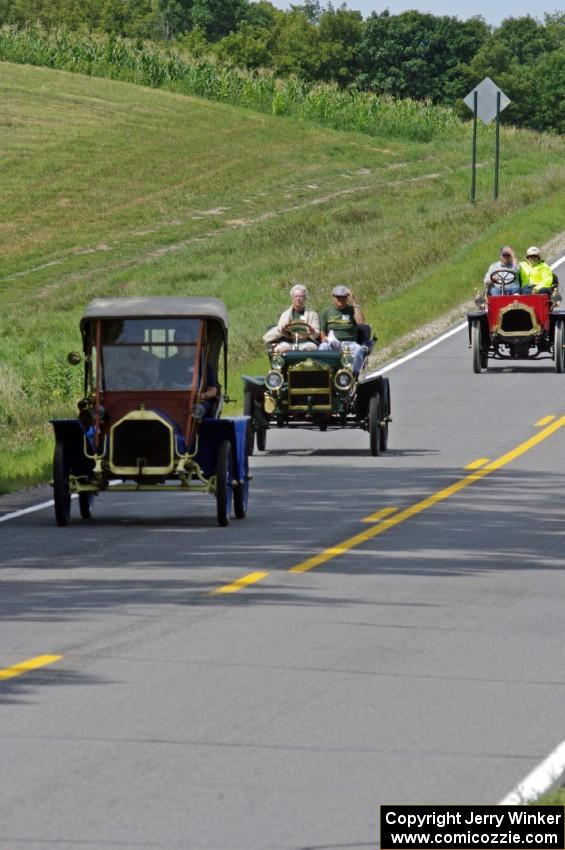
{"left": 0, "top": 252, "right": 565, "bottom": 850}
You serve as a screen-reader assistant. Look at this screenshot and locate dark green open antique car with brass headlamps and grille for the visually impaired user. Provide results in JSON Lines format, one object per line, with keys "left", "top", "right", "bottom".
{"left": 243, "top": 322, "right": 391, "bottom": 455}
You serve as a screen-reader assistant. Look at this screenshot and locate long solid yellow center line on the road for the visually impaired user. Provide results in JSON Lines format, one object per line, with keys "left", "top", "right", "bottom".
{"left": 289, "top": 416, "right": 565, "bottom": 573}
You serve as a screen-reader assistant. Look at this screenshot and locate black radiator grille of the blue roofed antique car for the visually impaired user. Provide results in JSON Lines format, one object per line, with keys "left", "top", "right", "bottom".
{"left": 110, "top": 418, "right": 174, "bottom": 475}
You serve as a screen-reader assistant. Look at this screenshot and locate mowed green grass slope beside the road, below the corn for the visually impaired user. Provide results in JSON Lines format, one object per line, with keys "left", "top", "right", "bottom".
{"left": 0, "top": 63, "right": 565, "bottom": 491}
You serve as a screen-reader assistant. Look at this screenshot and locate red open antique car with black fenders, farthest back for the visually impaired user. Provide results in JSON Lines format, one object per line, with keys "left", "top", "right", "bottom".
{"left": 467, "top": 270, "right": 565, "bottom": 373}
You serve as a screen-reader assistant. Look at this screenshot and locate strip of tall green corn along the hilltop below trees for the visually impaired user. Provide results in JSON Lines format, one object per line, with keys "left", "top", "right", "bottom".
{"left": 0, "top": 26, "right": 460, "bottom": 142}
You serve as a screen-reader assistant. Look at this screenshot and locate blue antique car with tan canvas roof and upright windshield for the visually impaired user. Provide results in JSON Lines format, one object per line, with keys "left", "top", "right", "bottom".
{"left": 52, "top": 297, "right": 249, "bottom": 526}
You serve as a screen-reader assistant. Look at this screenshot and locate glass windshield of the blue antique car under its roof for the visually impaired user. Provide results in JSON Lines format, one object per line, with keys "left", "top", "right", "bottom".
{"left": 101, "top": 319, "right": 201, "bottom": 390}
